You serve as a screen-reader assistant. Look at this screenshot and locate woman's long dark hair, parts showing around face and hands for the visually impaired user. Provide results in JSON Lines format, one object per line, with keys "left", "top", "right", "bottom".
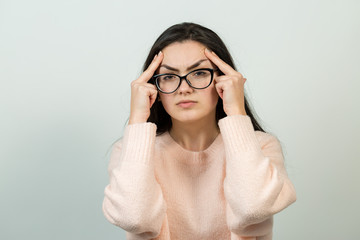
{"left": 143, "top": 22, "right": 265, "bottom": 135}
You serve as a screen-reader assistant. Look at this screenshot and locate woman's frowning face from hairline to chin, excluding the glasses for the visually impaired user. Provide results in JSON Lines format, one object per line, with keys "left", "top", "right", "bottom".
{"left": 157, "top": 41, "right": 219, "bottom": 123}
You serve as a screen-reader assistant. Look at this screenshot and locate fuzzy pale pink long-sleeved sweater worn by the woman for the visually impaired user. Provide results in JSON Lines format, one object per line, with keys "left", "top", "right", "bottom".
{"left": 103, "top": 115, "right": 296, "bottom": 240}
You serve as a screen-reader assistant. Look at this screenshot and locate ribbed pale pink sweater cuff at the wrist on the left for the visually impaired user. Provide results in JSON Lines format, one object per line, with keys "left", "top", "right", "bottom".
{"left": 122, "top": 122, "right": 157, "bottom": 164}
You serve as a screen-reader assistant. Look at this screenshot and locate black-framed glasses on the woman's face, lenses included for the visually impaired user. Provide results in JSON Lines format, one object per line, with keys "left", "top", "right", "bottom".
{"left": 153, "top": 68, "right": 218, "bottom": 93}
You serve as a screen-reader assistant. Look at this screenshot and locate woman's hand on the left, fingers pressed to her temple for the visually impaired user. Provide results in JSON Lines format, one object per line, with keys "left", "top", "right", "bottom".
{"left": 129, "top": 51, "right": 164, "bottom": 124}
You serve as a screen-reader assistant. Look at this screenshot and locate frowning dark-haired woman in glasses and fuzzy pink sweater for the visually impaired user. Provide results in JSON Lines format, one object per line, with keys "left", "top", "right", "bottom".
{"left": 103, "top": 23, "right": 296, "bottom": 240}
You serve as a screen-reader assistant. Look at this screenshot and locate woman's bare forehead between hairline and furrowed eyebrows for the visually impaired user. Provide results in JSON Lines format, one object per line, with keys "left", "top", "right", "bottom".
{"left": 162, "top": 40, "right": 207, "bottom": 66}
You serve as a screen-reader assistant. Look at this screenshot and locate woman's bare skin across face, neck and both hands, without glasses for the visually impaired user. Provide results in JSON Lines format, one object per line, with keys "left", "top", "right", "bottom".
{"left": 129, "top": 40, "right": 246, "bottom": 151}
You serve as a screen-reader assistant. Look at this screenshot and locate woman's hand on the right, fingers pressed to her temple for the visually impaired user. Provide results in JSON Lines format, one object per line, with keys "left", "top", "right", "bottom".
{"left": 205, "top": 48, "right": 246, "bottom": 116}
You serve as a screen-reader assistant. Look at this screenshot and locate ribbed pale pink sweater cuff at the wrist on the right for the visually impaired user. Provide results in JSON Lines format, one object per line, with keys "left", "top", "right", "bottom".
{"left": 219, "top": 115, "right": 261, "bottom": 152}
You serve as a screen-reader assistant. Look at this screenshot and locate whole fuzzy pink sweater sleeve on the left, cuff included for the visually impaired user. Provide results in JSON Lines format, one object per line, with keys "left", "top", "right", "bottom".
{"left": 102, "top": 123, "right": 166, "bottom": 239}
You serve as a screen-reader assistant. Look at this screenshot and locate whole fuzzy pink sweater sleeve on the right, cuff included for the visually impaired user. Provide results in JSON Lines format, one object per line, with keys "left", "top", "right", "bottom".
{"left": 219, "top": 115, "right": 296, "bottom": 237}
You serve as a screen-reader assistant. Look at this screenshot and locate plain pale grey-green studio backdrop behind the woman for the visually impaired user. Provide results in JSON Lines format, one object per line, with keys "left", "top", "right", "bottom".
{"left": 0, "top": 0, "right": 360, "bottom": 240}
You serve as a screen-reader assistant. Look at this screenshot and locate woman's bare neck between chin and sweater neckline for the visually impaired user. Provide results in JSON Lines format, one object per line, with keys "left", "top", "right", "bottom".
{"left": 169, "top": 116, "right": 220, "bottom": 151}
